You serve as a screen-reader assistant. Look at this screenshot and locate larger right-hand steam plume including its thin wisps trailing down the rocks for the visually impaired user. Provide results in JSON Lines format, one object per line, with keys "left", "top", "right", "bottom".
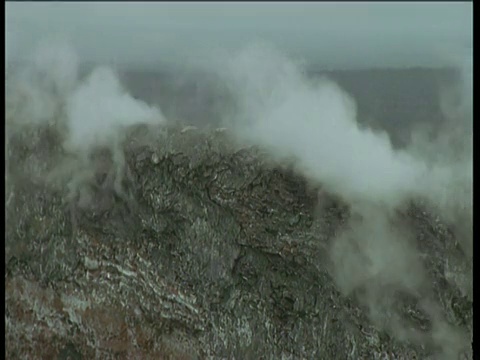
{"left": 210, "top": 45, "right": 472, "bottom": 358}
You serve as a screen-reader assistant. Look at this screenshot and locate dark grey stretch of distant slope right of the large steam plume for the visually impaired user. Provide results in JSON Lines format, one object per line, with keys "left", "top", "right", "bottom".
{"left": 329, "top": 68, "right": 455, "bottom": 146}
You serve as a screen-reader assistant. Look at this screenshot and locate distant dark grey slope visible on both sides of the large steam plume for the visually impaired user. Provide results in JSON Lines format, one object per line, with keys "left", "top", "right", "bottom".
{"left": 118, "top": 68, "right": 455, "bottom": 146}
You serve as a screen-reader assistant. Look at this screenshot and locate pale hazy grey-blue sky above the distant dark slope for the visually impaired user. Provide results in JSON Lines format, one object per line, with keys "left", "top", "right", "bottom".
{"left": 6, "top": 2, "right": 473, "bottom": 68}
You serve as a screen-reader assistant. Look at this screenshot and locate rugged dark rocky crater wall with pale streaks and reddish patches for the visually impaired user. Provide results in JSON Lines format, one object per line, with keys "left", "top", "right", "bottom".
{"left": 5, "top": 117, "right": 472, "bottom": 359}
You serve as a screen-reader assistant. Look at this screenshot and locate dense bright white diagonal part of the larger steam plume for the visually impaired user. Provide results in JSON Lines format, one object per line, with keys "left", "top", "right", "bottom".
{"left": 217, "top": 45, "right": 427, "bottom": 202}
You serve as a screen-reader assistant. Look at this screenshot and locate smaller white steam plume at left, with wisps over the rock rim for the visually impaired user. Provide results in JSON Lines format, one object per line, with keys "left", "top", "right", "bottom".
{"left": 7, "top": 42, "right": 165, "bottom": 205}
